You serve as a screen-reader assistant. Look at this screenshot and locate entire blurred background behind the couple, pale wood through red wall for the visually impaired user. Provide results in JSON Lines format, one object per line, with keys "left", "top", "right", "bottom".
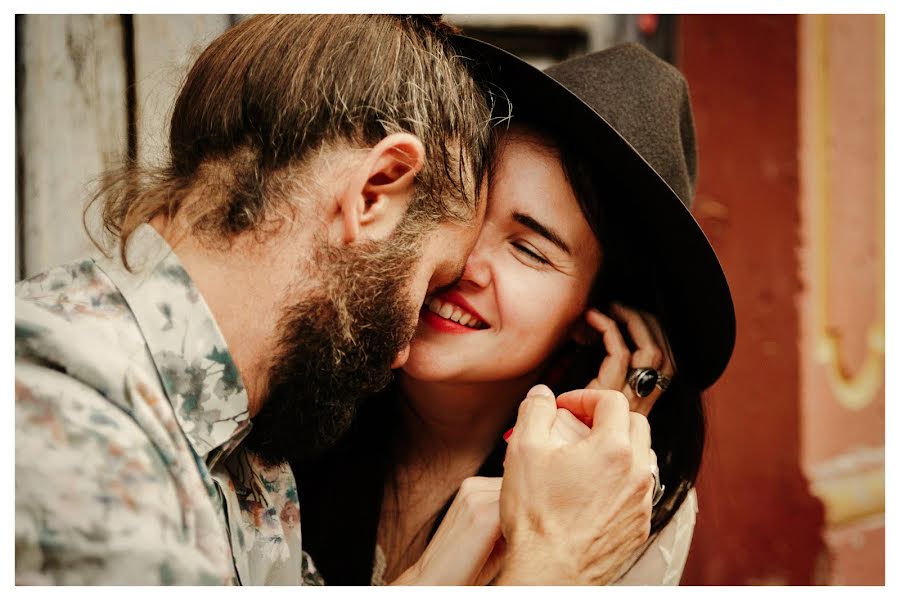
{"left": 15, "top": 15, "right": 885, "bottom": 585}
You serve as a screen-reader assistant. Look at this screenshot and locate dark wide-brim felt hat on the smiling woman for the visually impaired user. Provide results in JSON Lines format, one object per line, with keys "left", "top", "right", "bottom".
{"left": 452, "top": 35, "right": 735, "bottom": 390}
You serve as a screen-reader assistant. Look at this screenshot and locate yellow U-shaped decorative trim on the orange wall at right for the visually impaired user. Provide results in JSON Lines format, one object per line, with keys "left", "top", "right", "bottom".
{"left": 807, "top": 15, "right": 885, "bottom": 410}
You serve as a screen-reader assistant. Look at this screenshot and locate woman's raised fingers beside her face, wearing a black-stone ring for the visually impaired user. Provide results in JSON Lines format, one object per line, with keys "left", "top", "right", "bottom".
{"left": 576, "top": 303, "right": 675, "bottom": 418}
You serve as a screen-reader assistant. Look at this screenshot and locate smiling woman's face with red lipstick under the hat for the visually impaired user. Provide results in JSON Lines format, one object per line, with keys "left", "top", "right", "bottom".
{"left": 404, "top": 132, "right": 601, "bottom": 383}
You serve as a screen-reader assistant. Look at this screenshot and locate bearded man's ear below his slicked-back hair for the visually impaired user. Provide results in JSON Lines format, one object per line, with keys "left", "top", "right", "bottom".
{"left": 339, "top": 133, "right": 425, "bottom": 244}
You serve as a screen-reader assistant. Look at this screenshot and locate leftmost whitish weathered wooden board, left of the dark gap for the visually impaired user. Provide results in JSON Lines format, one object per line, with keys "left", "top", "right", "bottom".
{"left": 16, "top": 15, "right": 128, "bottom": 276}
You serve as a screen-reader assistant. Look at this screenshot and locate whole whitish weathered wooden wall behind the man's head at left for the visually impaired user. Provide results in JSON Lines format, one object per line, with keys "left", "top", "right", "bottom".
{"left": 16, "top": 15, "right": 234, "bottom": 278}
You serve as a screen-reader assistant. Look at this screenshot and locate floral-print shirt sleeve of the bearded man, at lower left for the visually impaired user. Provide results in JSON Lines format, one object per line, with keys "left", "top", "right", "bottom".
{"left": 15, "top": 358, "right": 225, "bottom": 585}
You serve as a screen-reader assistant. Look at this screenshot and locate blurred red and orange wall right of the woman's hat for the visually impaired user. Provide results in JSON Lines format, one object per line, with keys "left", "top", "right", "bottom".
{"left": 676, "top": 15, "right": 885, "bottom": 584}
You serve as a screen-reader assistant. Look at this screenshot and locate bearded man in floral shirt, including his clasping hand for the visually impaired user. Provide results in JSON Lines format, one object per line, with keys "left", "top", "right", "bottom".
{"left": 16, "top": 15, "right": 649, "bottom": 584}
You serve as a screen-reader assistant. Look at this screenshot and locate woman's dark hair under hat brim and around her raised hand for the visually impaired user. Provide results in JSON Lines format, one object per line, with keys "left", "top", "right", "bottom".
{"left": 544, "top": 124, "right": 706, "bottom": 535}
